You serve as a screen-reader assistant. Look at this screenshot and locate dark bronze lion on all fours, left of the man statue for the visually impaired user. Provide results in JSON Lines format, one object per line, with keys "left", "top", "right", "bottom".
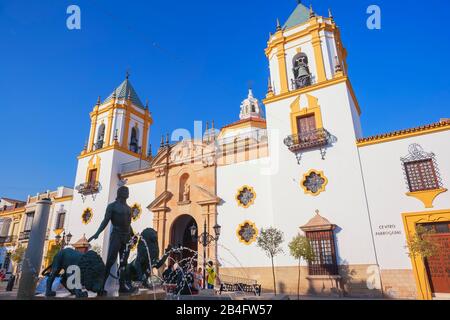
{"left": 42, "top": 248, "right": 106, "bottom": 298}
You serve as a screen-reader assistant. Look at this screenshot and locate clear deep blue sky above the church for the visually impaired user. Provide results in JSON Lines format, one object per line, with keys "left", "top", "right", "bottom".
{"left": 0, "top": 0, "right": 450, "bottom": 199}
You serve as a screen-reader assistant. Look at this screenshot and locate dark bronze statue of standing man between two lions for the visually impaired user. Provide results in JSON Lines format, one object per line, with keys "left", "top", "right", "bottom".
{"left": 88, "top": 186, "right": 137, "bottom": 293}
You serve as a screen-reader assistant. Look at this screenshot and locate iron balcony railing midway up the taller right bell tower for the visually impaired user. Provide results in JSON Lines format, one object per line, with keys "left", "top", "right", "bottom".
{"left": 284, "top": 129, "right": 331, "bottom": 152}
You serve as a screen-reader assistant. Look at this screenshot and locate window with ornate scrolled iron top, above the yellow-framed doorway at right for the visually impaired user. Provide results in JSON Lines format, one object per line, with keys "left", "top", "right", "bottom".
{"left": 400, "top": 143, "right": 442, "bottom": 192}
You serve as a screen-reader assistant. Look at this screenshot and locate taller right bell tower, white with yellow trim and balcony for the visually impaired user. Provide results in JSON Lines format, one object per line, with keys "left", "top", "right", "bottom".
{"left": 263, "top": 1, "right": 376, "bottom": 272}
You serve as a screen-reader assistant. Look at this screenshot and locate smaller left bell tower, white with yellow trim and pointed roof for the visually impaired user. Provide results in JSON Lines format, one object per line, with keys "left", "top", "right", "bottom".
{"left": 69, "top": 73, "right": 153, "bottom": 254}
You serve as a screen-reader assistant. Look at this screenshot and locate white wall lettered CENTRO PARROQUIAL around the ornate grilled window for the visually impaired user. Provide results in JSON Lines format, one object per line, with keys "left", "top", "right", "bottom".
{"left": 359, "top": 131, "right": 450, "bottom": 269}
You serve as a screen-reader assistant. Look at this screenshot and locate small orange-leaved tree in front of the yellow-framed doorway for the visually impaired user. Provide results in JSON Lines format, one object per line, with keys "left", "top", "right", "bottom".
{"left": 407, "top": 225, "right": 439, "bottom": 296}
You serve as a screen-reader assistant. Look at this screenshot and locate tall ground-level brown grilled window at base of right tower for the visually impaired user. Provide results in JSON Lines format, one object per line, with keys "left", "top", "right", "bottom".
{"left": 306, "top": 230, "right": 339, "bottom": 276}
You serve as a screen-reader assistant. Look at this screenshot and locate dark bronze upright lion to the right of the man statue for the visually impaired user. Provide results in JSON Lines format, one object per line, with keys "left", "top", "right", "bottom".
{"left": 124, "top": 228, "right": 171, "bottom": 288}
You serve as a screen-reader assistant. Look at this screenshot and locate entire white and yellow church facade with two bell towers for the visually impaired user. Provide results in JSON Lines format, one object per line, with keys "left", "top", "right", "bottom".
{"left": 0, "top": 4, "right": 450, "bottom": 299}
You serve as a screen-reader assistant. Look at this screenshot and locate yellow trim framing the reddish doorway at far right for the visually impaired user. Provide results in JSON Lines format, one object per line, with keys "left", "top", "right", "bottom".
{"left": 402, "top": 209, "right": 450, "bottom": 300}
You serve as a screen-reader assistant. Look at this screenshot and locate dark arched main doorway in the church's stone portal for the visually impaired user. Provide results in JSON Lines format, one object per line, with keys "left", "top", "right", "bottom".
{"left": 169, "top": 214, "right": 198, "bottom": 264}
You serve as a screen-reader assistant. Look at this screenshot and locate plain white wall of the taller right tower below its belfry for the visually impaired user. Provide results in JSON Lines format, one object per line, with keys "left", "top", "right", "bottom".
{"left": 266, "top": 83, "right": 375, "bottom": 265}
